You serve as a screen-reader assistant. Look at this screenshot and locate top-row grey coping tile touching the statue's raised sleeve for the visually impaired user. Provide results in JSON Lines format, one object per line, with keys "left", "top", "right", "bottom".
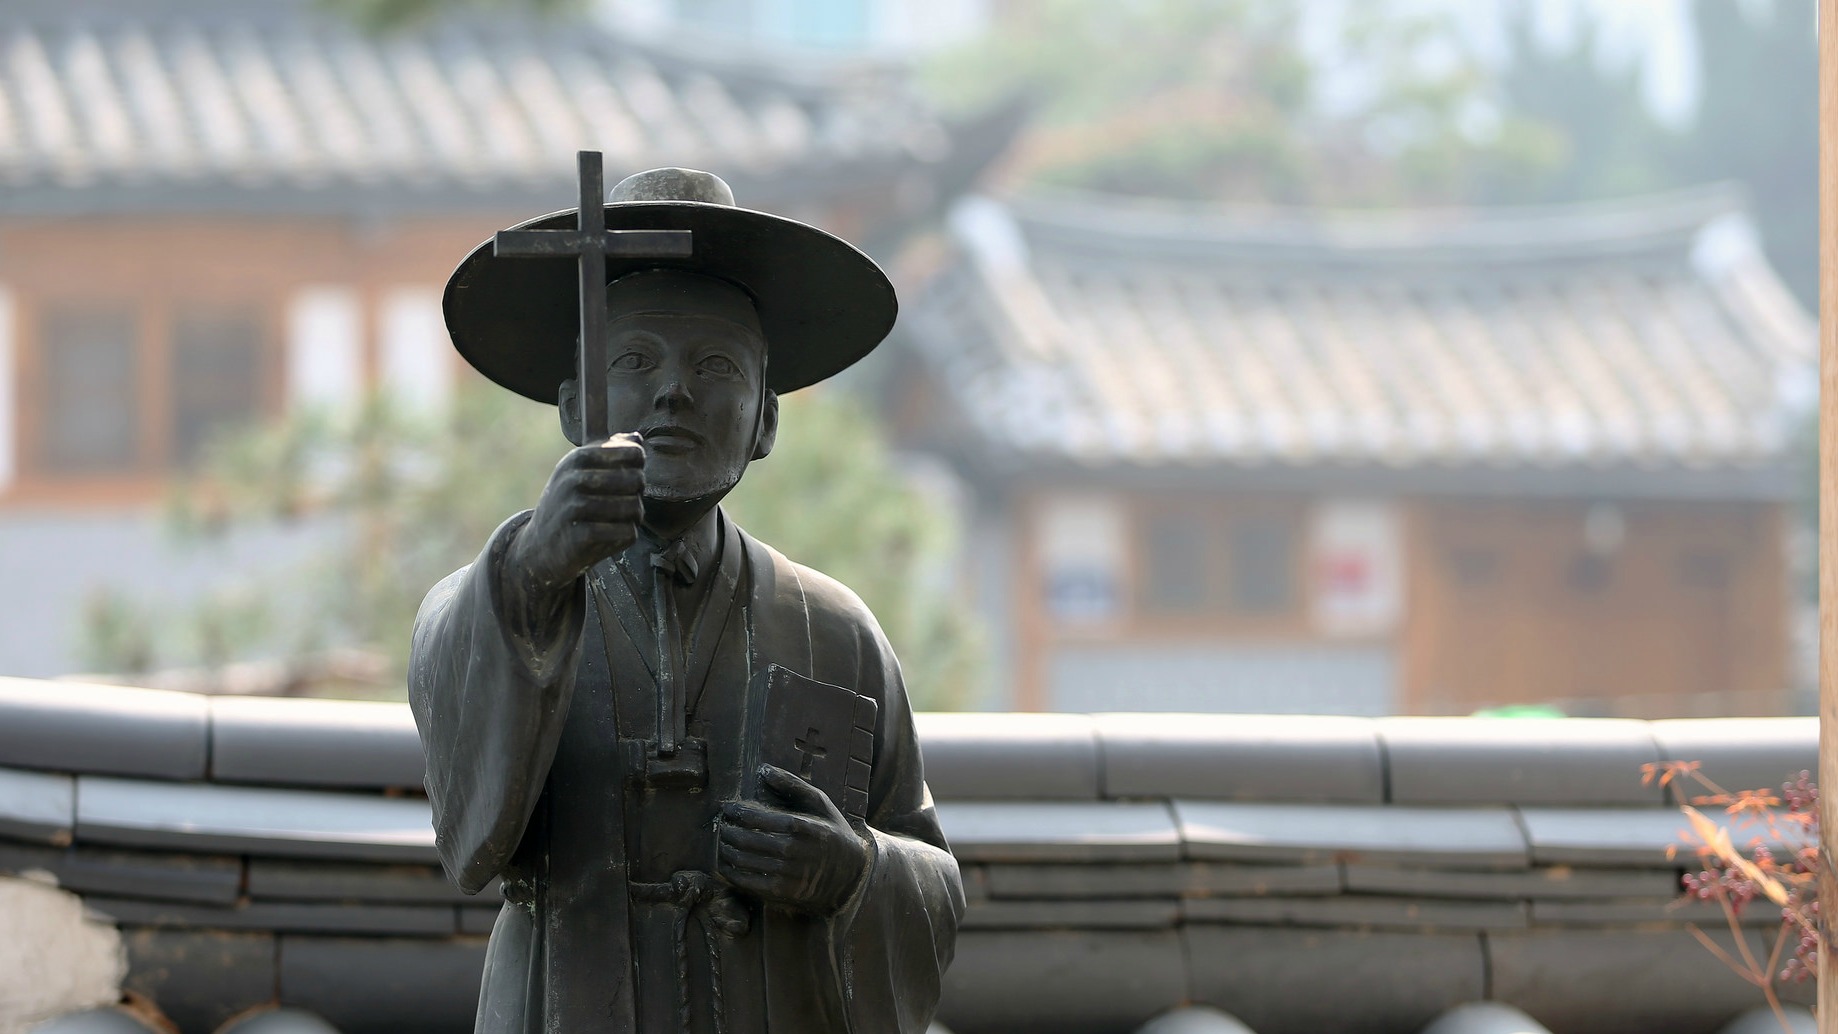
{"left": 210, "top": 696, "right": 425, "bottom": 790}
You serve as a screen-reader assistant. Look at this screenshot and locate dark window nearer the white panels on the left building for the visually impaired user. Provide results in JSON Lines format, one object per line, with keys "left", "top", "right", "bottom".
{"left": 171, "top": 309, "right": 267, "bottom": 463}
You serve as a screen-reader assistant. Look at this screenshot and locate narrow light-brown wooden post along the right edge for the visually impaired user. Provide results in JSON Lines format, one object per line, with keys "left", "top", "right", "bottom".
{"left": 1818, "top": 0, "right": 1838, "bottom": 1034}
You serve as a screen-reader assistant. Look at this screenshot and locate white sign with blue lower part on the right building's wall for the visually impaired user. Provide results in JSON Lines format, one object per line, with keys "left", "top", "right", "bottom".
{"left": 1037, "top": 496, "right": 1129, "bottom": 624}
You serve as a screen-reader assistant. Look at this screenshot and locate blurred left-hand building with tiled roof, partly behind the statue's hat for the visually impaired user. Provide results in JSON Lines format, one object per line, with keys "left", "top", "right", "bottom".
{"left": 0, "top": 0, "right": 1007, "bottom": 674}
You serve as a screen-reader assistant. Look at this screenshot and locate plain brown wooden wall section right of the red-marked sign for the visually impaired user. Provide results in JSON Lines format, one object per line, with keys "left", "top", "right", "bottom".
{"left": 1401, "top": 501, "right": 1790, "bottom": 716}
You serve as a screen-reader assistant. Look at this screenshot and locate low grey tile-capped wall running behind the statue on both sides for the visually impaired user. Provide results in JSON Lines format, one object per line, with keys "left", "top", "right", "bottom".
{"left": 0, "top": 680, "right": 1818, "bottom": 1034}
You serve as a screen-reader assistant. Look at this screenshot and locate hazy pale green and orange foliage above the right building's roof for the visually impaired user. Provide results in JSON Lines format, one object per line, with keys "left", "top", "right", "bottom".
{"left": 925, "top": 0, "right": 1521, "bottom": 204}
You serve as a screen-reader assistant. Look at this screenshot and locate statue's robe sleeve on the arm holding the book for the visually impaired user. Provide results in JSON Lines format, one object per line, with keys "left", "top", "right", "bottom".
{"left": 833, "top": 608, "right": 963, "bottom": 1034}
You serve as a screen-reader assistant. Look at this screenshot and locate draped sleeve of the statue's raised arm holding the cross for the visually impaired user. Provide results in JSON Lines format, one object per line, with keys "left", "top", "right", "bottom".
{"left": 408, "top": 511, "right": 586, "bottom": 894}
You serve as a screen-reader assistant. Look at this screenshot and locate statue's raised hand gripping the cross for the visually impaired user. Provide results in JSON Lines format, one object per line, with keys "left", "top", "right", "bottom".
{"left": 505, "top": 433, "right": 645, "bottom": 593}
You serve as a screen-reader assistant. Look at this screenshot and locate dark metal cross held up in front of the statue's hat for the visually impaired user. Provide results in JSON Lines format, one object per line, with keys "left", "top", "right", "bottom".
{"left": 491, "top": 151, "right": 695, "bottom": 441}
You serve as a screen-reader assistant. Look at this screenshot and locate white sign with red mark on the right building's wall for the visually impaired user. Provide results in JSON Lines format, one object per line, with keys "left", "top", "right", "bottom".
{"left": 1309, "top": 500, "right": 1404, "bottom": 637}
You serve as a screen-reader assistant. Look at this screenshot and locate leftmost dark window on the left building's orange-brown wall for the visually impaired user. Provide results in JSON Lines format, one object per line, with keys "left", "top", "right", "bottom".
{"left": 37, "top": 305, "right": 142, "bottom": 474}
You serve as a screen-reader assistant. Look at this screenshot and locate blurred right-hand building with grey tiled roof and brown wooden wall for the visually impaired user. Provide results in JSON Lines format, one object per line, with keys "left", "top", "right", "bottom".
{"left": 895, "top": 187, "right": 1816, "bottom": 714}
